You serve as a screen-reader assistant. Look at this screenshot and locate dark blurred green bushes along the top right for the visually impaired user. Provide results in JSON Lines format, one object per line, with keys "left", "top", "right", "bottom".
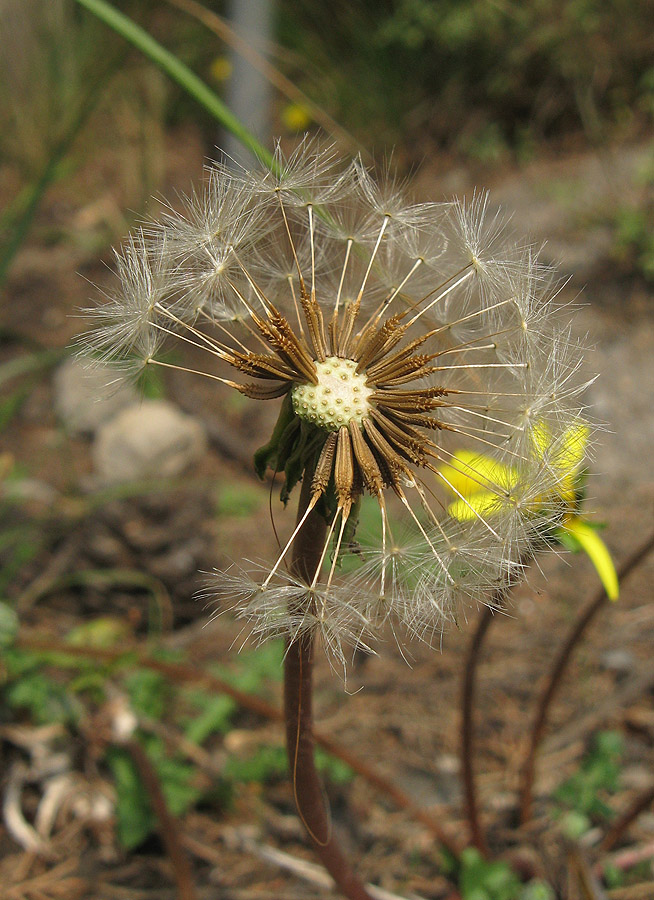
{"left": 281, "top": 0, "right": 654, "bottom": 151}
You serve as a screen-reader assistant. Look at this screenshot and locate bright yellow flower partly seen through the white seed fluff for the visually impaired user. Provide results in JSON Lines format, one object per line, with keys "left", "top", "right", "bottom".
{"left": 440, "top": 422, "right": 620, "bottom": 600}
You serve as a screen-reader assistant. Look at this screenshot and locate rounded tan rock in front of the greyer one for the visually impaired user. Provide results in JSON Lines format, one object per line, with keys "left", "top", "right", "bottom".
{"left": 93, "top": 400, "right": 207, "bottom": 484}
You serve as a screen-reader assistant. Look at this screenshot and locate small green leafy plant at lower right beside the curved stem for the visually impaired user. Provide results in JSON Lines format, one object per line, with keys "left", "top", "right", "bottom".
{"left": 554, "top": 731, "right": 624, "bottom": 839}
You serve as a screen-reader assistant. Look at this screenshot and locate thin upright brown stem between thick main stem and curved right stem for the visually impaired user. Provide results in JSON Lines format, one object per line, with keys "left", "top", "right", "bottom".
{"left": 460, "top": 592, "right": 503, "bottom": 856}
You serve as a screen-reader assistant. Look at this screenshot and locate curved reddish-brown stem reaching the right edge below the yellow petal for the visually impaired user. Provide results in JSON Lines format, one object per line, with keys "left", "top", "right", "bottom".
{"left": 520, "top": 534, "right": 654, "bottom": 825}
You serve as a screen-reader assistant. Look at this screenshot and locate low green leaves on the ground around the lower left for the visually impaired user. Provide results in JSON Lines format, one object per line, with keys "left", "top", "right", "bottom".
{"left": 0, "top": 616, "right": 292, "bottom": 849}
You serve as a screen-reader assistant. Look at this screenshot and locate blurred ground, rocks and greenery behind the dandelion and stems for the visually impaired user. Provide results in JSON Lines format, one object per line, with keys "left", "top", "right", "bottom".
{"left": 0, "top": 0, "right": 654, "bottom": 900}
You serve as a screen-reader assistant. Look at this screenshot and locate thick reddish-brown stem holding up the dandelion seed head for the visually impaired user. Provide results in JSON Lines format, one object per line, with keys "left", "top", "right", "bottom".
{"left": 284, "top": 472, "right": 371, "bottom": 900}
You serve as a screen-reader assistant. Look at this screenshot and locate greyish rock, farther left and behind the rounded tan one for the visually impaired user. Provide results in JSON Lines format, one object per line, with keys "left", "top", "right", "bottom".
{"left": 54, "top": 357, "right": 138, "bottom": 434}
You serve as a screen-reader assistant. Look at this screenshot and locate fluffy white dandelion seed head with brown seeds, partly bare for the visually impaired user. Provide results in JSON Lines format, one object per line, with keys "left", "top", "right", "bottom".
{"left": 83, "top": 141, "right": 587, "bottom": 664}
